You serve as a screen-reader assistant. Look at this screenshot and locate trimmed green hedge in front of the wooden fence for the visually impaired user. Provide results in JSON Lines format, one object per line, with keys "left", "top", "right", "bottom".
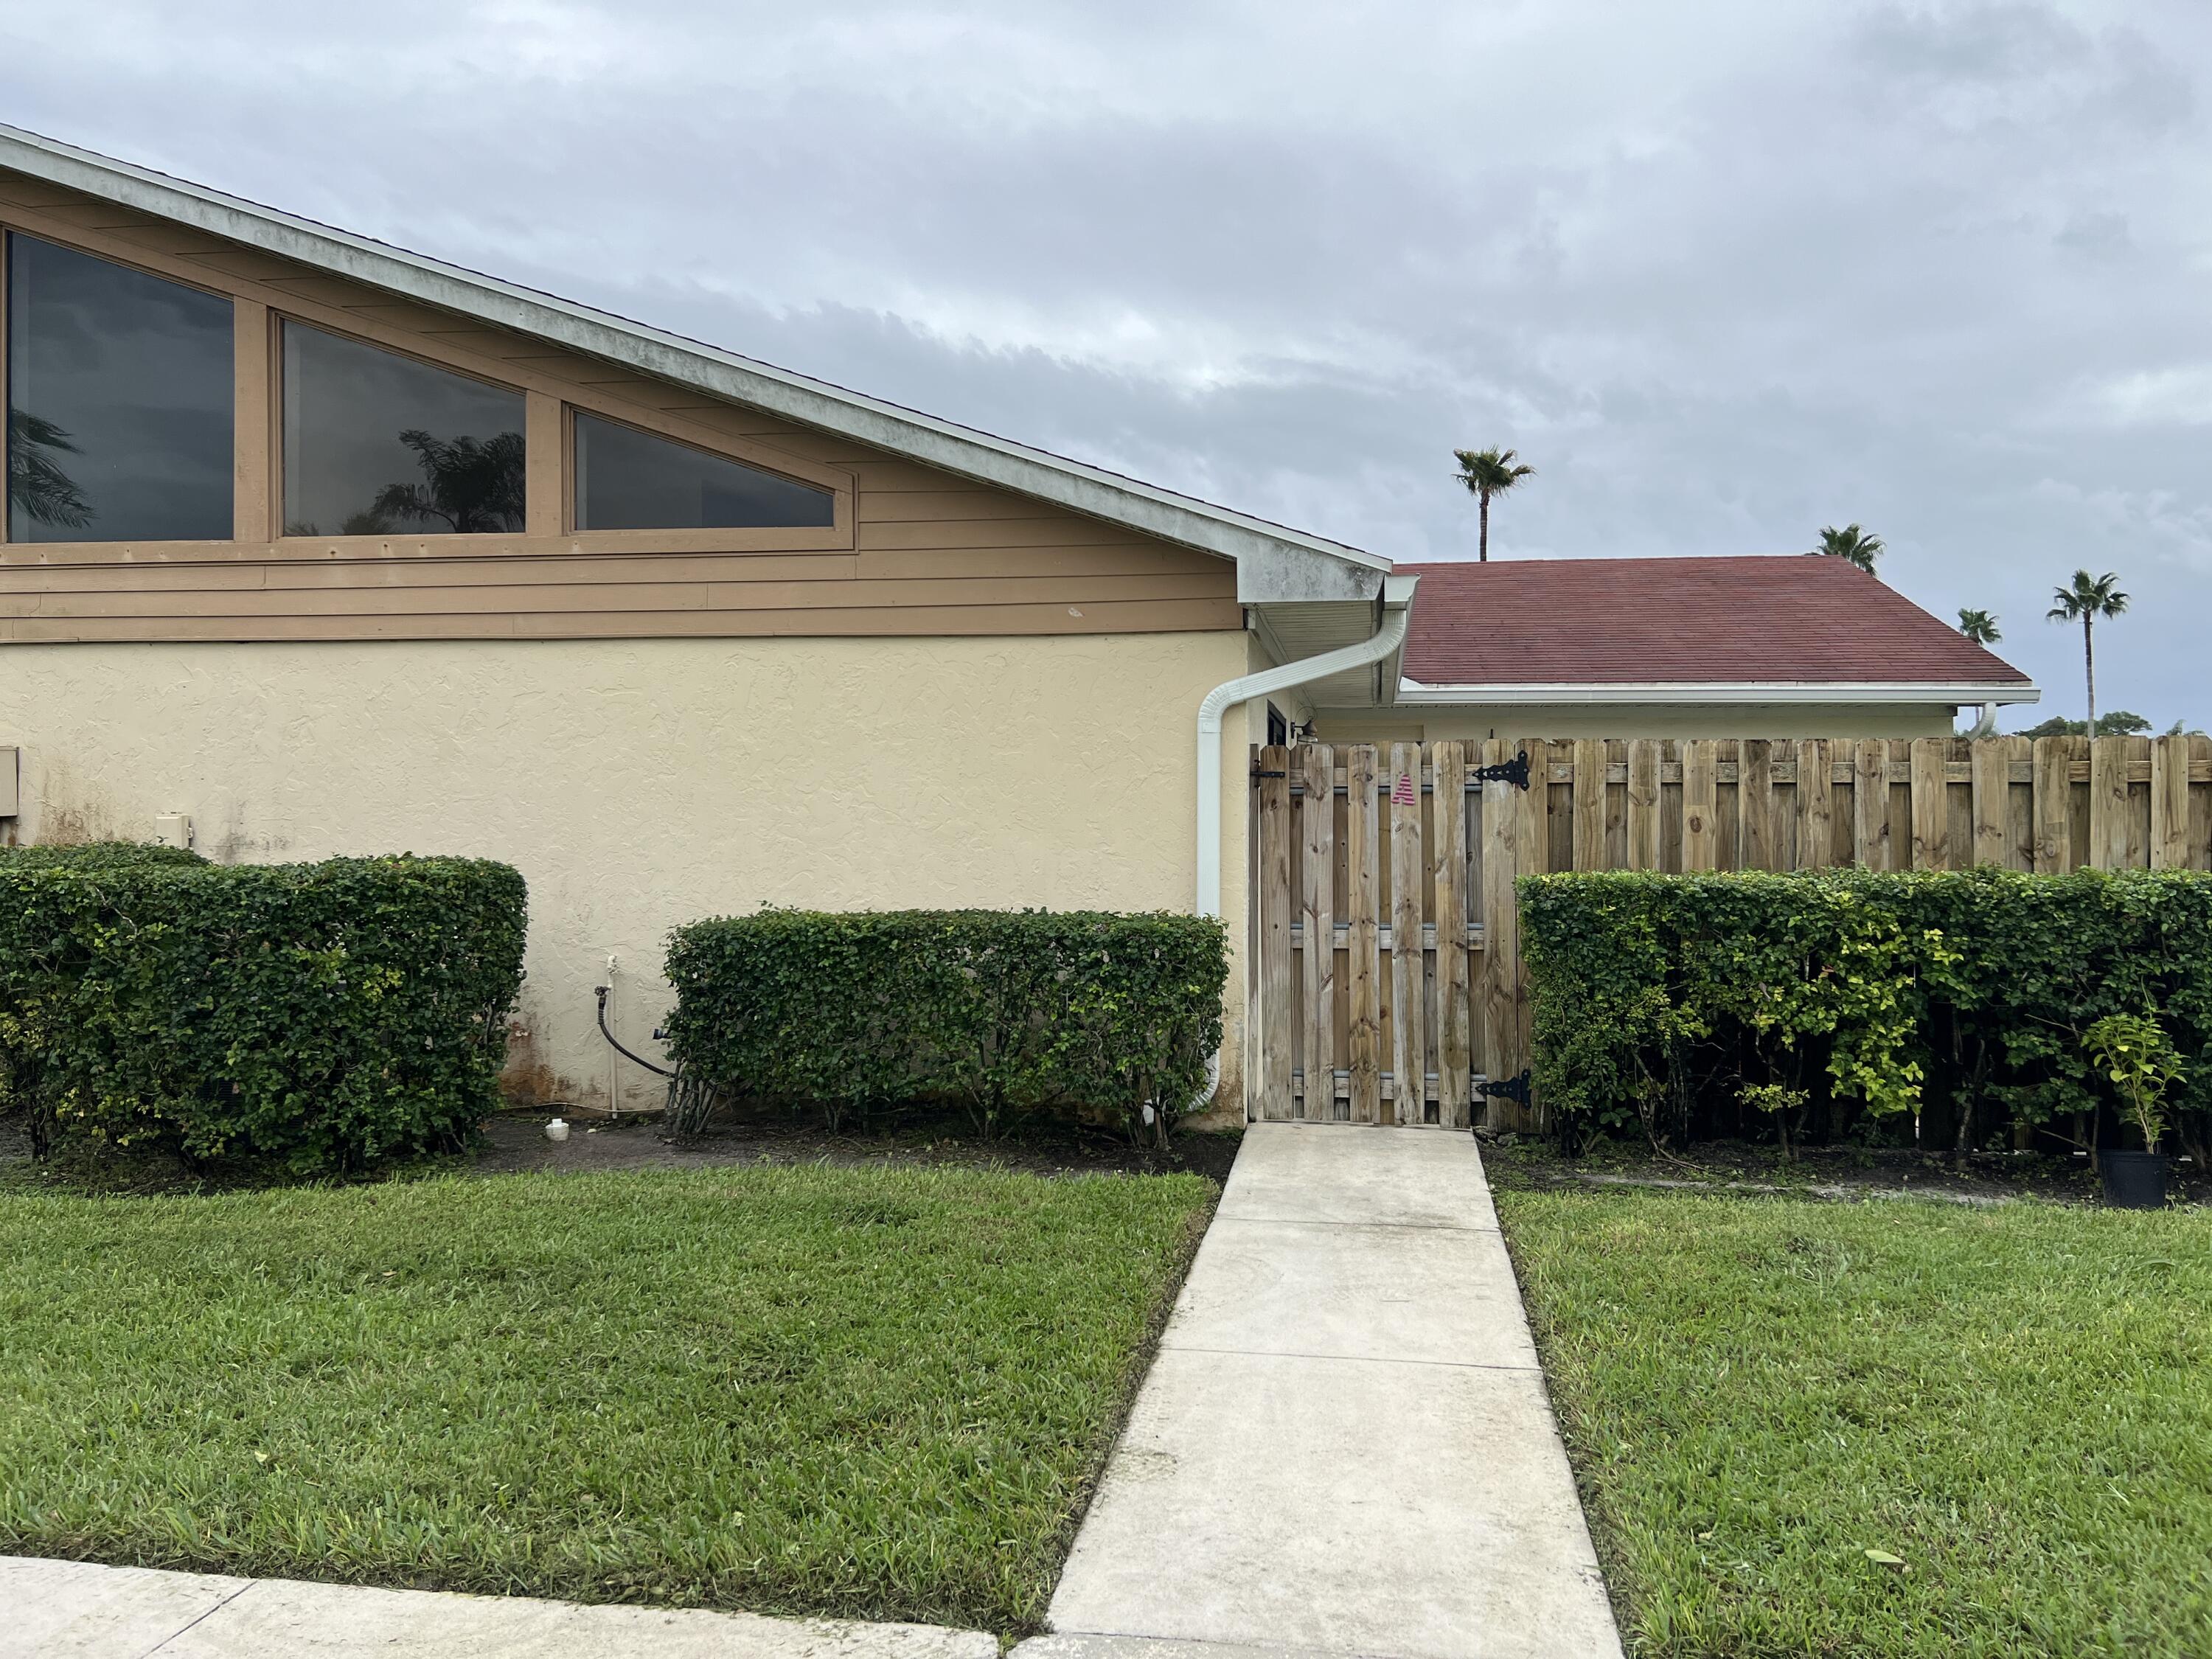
{"left": 1517, "top": 867, "right": 2212, "bottom": 1157}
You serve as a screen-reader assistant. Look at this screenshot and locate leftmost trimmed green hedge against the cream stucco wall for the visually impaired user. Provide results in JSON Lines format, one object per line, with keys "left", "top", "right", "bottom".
{"left": 0, "top": 845, "right": 526, "bottom": 1175}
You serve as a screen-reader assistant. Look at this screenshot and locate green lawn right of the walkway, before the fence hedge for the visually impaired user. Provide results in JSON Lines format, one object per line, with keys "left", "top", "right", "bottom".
{"left": 1498, "top": 1192, "right": 2212, "bottom": 1659}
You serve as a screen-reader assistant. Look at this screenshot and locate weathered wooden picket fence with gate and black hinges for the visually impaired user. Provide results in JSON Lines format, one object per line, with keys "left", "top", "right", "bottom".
{"left": 1248, "top": 737, "right": 2212, "bottom": 1128}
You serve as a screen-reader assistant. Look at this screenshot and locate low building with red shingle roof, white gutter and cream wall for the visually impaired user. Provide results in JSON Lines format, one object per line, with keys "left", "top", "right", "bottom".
{"left": 1316, "top": 555, "right": 2042, "bottom": 739}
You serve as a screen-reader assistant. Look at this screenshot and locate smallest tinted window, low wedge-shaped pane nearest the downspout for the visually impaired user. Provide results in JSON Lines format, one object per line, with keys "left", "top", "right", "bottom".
{"left": 575, "top": 414, "right": 836, "bottom": 531}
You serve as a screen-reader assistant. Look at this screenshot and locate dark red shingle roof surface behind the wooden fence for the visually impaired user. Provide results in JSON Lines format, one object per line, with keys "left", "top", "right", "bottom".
{"left": 1398, "top": 555, "right": 2028, "bottom": 686}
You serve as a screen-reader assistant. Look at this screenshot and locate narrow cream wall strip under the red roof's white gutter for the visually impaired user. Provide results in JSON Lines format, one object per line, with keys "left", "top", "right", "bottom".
{"left": 1314, "top": 703, "right": 1958, "bottom": 743}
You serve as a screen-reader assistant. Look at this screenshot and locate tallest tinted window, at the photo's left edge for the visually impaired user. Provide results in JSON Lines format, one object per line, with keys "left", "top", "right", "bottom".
{"left": 7, "top": 237, "right": 234, "bottom": 542}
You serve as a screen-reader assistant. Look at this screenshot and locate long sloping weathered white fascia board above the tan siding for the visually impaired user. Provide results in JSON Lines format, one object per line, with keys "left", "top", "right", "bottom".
{"left": 0, "top": 126, "right": 1391, "bottom": 604}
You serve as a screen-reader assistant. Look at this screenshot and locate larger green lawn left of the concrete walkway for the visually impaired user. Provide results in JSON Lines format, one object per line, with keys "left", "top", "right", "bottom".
{"left": 0, "top": 1166, "right": 1214, "bottom": 1632}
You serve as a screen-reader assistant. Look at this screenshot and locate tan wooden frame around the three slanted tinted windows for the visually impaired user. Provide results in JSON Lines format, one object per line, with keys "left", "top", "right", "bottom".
{"left": 0, "top": 206, "right": 858, "bottom": 564}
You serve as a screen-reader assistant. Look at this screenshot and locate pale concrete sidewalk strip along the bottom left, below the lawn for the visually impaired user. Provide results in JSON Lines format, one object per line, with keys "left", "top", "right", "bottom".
{"left": 0, "top": 1555, "right": 998, "bottom": 1659}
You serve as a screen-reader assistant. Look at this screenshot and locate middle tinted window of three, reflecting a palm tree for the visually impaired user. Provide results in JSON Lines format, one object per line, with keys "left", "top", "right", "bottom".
{"left": 283, "top": 323, "right": 522, "bottom": 535}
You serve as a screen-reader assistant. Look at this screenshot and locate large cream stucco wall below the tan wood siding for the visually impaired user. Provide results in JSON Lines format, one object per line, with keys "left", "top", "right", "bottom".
{"left": 0, "top": 633, "right": 1254, "bottom": 1108}
